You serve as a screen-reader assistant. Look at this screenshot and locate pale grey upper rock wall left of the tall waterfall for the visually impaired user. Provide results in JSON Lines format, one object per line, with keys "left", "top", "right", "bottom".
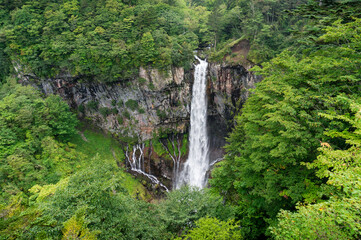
{"left": 22, "top": 65, "right": 191, "bottom": 141}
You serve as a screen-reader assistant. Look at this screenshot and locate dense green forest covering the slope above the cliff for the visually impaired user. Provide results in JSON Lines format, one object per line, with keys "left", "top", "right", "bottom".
{"left": 0, "top": 0, "right": 305, "bottom": 81}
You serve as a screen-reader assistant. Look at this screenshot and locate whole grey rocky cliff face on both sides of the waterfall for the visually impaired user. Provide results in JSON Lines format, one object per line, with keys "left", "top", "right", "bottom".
{"left": 20, "top": 63, "right": 260, "bottom": 188}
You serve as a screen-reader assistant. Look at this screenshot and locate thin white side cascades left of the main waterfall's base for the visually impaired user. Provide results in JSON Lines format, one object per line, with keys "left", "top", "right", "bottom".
{"left": 125, "top": 143, "right": 169, "bottom": 192}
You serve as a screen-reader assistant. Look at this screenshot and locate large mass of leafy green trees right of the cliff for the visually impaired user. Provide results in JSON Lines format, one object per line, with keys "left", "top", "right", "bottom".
{"left": 212, "top": 3, "right": 361, "bottom": 239}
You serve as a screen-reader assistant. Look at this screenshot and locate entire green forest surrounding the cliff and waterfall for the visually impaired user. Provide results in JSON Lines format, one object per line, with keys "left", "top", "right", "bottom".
{"left": 0, "top": 0, "right": 361, "bottom": 240}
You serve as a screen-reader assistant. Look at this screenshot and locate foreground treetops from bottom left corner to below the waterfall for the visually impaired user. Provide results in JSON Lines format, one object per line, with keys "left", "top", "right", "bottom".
{"left": 0, "top": 173, "right": 233, "bottom": 239}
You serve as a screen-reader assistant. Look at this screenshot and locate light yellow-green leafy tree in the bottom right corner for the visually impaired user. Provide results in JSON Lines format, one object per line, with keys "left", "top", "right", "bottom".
{"left": 270, "top": 99, "right": 361, "bottom": 239}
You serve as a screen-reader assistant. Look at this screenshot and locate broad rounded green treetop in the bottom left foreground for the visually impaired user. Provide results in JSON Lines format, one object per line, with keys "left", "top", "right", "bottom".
{"left": 4, "top": 163, "right": 169, "bottom": 239}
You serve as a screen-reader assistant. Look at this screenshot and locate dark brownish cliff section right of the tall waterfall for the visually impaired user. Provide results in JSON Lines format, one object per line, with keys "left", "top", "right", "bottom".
{"left": 208, "top": 63, "right": 262, "bottom": 163}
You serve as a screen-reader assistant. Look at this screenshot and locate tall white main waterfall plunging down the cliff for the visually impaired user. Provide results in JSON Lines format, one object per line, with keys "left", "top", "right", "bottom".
{"left": 176, "top": 56, "right": 209, "bottom": 188}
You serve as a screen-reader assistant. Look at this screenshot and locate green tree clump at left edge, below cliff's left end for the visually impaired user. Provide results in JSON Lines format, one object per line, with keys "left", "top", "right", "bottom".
{"left": 0, "top": 82, "right": 82, "bottom": 200}
